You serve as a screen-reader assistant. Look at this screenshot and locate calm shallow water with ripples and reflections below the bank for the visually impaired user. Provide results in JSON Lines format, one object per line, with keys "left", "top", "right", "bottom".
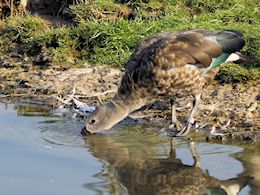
{"left": 0, "top": 104, "right": 260, "bottom": 195}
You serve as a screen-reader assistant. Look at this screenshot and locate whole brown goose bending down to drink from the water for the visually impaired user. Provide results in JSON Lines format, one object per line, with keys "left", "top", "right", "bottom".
{"left": 82, "top": 30, "right": 247, "bottom": 136}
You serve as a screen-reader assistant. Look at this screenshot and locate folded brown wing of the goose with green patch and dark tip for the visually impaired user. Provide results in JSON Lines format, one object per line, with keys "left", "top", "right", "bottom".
{"left": 119, "top": 30, "right": 244, "bottom": 96}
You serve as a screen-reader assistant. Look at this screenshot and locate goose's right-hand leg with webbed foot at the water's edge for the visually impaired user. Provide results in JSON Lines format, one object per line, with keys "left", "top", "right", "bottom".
{"left": 175, "top": 94, "right": 201, "bottom": 136}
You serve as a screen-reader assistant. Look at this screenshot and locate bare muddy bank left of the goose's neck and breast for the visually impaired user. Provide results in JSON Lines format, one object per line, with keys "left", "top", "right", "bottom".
{"left": 0, "top": 53, "right": 122, "bottom": 104}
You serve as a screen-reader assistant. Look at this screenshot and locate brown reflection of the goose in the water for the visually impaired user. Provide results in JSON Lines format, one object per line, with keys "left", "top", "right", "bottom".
{"left": 85, "top": 134, "right": 252, "bottom": 195}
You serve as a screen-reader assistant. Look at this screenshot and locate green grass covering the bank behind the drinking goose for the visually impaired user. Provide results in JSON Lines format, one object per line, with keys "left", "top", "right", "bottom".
{"left": 0, "top": 0, "right": 260, "bottom": 81}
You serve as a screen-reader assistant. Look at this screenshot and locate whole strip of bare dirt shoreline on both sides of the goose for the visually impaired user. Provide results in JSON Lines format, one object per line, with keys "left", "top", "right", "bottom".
{"left": 0, "top": 54, "right": 260, "bottom": 139}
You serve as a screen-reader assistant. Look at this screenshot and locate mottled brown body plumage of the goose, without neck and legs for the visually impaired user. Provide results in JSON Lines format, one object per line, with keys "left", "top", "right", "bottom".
{"left": 118, "top": 30, "right": 244, "bottom": 101}
